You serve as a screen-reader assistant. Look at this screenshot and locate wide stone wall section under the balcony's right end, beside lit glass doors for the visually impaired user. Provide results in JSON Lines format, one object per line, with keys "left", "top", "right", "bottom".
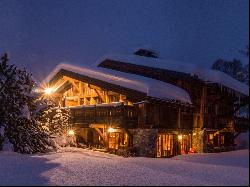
{"left": 132, "top": 129, "right": 158, "bottom": 157}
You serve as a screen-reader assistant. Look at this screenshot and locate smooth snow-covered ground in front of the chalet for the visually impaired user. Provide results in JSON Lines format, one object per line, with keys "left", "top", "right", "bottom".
{"left": 0, "top": 148, "right": 249, "bottom": 186}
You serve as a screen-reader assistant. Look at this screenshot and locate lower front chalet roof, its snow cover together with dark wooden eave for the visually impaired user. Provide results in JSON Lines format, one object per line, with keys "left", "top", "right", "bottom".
{"left": 43, "top": 64, "right": 192, "bottom": 105}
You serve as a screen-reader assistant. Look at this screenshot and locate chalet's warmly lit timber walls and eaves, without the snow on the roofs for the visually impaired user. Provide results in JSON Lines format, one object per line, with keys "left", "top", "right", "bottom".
{"left": 43, "top": 49, "right": 248, "bottom": 157}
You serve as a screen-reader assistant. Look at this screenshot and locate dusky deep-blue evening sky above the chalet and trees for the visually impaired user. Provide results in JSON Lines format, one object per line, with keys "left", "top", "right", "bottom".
{"left": 0, "top": 0, "right": 249, "bottom": 80}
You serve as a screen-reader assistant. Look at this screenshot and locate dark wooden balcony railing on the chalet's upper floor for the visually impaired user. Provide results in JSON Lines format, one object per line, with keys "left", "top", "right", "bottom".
{"left": 70, "top": 104, "right": 138, "bottom": 127}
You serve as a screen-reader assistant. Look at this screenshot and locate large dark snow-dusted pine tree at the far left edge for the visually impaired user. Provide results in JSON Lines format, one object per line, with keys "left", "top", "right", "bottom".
{"left": 0, "top": 54, "right": 54, "bottom": 153}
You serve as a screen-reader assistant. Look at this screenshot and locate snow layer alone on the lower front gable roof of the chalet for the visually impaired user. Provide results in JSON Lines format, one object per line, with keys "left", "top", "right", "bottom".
{"left": 43, "top": 63, "right": 192, "bottom": 104}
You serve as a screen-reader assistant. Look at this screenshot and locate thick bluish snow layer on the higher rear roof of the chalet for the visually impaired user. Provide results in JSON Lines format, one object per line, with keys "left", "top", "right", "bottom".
{"left": 96, "top": 55, "right": 249, "bottom": 96}
